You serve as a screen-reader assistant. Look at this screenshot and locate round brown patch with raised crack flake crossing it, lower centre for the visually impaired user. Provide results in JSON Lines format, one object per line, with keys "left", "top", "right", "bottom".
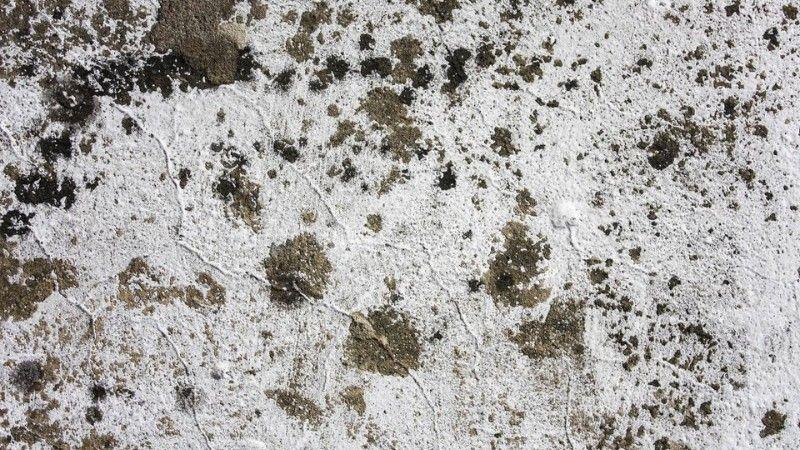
{"left": 345, "top": 306, "right": 422, "bottom": 376}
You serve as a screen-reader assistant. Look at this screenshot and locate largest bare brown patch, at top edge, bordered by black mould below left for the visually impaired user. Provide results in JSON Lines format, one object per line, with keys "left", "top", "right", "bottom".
{"left": 148, "top": 0, "right": 255, "bottom": 85}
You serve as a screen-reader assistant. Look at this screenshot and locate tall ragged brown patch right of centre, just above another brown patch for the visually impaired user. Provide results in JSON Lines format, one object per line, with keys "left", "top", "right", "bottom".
{"left": 483, "top": 221, "right": 550, "bottom": 307}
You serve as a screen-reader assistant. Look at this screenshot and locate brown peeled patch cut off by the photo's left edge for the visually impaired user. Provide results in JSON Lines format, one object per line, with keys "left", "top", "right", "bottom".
{"left": 0, "top": 238, "right": 78, "bottom": 320}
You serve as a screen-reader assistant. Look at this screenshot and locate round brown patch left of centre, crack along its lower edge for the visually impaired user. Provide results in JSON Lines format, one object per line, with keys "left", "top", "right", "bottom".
{"left": 264, "top": 233, "right": 333, "bottom": 306}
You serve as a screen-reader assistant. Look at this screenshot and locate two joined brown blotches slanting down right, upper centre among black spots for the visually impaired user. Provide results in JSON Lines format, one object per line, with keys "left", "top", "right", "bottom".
{"left": 359, "top": 87, "right": 422, "bottom": 162}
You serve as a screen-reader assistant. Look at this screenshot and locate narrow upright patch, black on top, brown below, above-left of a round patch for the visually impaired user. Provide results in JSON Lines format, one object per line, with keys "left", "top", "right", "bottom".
{"left": 213, "top": 155, "right": 262, "bottom": 232}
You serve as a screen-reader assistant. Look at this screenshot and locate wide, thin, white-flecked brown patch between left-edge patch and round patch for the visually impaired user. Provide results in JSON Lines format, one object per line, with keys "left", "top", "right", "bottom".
{"left": 117, "top": 257, "right": 225, "bottom": 309}
